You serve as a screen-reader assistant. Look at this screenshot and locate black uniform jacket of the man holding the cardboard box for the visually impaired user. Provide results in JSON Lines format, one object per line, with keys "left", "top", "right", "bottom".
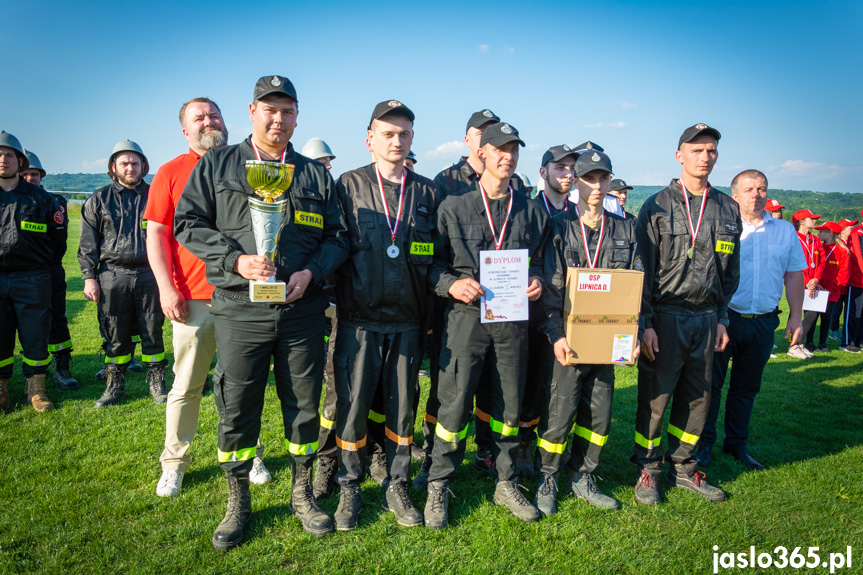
{"left": 539, "top": 207, "right": 641, "bottom": 343}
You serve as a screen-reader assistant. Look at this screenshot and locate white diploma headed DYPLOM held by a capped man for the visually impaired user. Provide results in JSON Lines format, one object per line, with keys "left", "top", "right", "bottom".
{"left": 479, "top": 250, "right": 529, "bottom": 323}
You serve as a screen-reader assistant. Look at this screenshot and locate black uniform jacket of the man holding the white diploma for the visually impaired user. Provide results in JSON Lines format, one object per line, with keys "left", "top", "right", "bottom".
{"left": 429, "top": 181, "right": 551, "bottom": 314}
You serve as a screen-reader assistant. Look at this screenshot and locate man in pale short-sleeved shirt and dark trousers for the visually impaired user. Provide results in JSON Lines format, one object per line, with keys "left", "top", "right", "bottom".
{"left": 695, "top": 170, "right": 806, "bottom": 470}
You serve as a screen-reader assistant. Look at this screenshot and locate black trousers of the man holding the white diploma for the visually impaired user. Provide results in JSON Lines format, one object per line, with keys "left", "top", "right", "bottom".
{"left": 429, "top": 303, "right": 527, "bottom": 481}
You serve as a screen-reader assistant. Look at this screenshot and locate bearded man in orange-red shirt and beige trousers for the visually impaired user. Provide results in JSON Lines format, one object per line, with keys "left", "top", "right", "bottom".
{"left": 144, "top": 98, "right": 271, "bottom": 497}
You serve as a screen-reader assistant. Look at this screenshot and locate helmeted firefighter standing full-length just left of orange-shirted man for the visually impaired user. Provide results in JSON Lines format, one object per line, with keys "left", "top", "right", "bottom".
{"left": 78, "top": 140, "right": 167, "bottom": 408}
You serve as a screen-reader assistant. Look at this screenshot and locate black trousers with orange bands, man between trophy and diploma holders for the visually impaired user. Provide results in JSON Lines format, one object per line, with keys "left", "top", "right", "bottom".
{"left": 333, "top": 326, "right": 422, "bottom": 485}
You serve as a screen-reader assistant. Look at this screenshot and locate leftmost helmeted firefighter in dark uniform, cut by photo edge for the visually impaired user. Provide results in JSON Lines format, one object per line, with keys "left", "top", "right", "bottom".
{"left": 0, "top": 132, "right": 67, "bottom": 413}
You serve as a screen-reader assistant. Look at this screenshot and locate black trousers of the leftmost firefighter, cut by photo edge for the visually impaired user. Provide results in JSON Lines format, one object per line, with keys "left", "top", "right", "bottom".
{"left": 0, "top": 270, "right": 51, "bottom": 379}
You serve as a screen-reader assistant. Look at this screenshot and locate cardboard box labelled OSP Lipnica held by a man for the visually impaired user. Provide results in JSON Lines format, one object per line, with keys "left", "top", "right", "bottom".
{"left": 563, "top": 268, "right": 644, "bottom": 365}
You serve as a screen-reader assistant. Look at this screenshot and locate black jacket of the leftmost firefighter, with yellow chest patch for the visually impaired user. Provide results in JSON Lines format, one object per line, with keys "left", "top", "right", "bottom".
{"left": 0, "top": 178, "right": 67, "bottom": 273}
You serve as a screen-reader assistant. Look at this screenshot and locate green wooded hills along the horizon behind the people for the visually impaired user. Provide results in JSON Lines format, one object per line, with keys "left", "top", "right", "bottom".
{"left": 42, "top": 174, "right": 863, "bottom": 222}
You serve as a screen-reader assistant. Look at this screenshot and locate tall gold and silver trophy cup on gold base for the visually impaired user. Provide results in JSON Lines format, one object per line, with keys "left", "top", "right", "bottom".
{"left": 246, "top": 160, "right": 294, "bottom": 303}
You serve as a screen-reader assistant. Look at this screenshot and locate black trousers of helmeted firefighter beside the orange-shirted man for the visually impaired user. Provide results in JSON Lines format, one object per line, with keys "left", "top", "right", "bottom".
{"left": 99, "top": 266, "right": 165, "bottom": 371}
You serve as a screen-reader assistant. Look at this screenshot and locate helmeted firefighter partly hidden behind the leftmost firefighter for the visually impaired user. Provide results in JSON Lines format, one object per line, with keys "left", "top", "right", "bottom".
{"left": 21, "top": 150, "right": 78, "bottom": 389}
